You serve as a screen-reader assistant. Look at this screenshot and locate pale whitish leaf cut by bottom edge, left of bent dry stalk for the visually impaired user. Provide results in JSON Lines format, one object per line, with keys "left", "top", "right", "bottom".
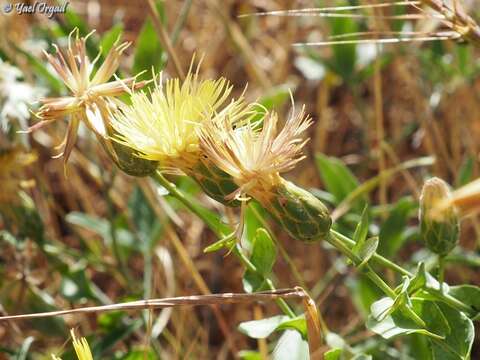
{"left": 272, "top": 330, "right": 310, "bottom": 360}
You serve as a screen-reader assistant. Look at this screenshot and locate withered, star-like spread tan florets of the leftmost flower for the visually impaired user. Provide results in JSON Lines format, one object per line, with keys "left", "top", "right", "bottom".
{"left": 29, "top": 30, "right": 145, "bottom": 161}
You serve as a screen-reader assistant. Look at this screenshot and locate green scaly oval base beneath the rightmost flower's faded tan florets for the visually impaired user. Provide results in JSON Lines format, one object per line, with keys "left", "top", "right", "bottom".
{"left": 257, "top": 179, "right": 332, "bottom": 242}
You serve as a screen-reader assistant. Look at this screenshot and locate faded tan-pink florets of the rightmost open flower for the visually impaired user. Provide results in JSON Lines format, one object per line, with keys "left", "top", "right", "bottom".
{"left": 201, "top": 104, "right": 311, "bottom": 198}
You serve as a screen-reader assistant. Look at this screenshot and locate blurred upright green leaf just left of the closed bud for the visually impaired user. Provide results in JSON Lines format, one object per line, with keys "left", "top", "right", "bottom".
{"left": 378, "top": 197, "right": 417, "bottom": 258}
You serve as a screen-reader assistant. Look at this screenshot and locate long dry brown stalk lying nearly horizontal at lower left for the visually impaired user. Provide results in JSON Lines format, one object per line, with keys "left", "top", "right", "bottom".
{"left": 0, "top": 288, "right": 306, "bottom": 321}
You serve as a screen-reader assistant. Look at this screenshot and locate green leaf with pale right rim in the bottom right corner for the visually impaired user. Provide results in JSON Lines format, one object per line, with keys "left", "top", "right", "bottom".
{"left": 432, "top": 303, "right": 475, "bottom": 360}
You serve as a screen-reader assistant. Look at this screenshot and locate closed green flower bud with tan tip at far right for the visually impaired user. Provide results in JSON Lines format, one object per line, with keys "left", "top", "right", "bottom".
{"left": 419, "top": 177, "right": 460, "bottom": 256}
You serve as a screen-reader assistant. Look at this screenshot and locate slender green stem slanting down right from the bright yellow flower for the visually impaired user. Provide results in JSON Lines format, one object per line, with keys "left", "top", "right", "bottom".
{"left": 153, "top": 172, "right": 296, "bottom": 318}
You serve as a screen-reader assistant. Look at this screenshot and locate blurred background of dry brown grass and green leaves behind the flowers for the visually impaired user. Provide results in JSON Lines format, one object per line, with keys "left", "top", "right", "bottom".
{"left": 0, "top": 0, "right": 480, "bottom": 359}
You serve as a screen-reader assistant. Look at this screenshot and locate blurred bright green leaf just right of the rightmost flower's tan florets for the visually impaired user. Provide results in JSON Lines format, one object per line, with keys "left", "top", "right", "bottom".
{"left": 315, "top": 154, "right": 365, "bottom": 209}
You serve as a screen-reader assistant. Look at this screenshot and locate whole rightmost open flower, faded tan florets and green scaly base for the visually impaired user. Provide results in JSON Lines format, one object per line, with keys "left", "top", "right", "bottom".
{"left": 201, "top": 109, "right": 331, "bottom": 242}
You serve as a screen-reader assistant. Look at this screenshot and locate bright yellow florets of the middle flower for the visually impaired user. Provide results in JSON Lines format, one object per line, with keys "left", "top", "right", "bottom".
{"left": 111, "top": 67, "right": 239, "bottom": 171}
